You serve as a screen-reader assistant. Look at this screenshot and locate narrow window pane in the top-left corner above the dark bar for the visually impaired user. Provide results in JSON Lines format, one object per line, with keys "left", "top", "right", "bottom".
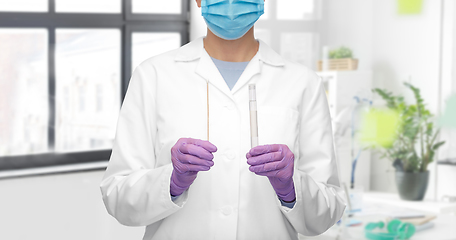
{"left": 0, "top": 0, "right": 48, "bottom": 12}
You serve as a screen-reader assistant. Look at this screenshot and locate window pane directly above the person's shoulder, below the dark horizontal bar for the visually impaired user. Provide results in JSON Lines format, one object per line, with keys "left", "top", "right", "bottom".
{"left": 132, "top": 33, "right": 181, "bottom": 70}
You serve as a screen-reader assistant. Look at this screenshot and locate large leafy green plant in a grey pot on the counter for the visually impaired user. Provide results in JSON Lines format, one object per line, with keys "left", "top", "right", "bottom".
{"left": 373, "top": 83, "right": 445, "bottom": 201}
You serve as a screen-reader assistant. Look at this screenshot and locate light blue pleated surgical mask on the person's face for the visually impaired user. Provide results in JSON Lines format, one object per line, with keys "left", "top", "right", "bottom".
{"left": 201, "top": 0, "right": 264, "bottom": 40}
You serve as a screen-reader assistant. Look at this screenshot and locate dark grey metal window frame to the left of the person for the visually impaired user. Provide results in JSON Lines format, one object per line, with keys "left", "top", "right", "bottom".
{"left": 0, "top": 0, "right": 189, "bottom": 179}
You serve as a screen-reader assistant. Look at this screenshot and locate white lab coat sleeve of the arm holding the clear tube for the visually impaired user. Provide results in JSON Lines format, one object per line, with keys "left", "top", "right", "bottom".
{"left": 280, "top": 71, "right": 346, "bottom": 236}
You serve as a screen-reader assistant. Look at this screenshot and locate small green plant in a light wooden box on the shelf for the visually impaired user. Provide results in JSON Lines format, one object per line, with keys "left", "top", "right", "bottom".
{"left": 318, "top": 46, "right": 358, "bottom": 71}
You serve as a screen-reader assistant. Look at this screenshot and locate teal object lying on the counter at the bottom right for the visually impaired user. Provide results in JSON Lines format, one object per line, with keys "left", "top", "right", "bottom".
{"left": 364, "top": 219, "right": 416, "bottom": 240}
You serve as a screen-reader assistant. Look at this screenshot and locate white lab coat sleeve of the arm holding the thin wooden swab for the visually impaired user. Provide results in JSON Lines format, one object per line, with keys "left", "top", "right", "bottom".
{"left": 100, "top": 62, "right": 187, "bottom": 226}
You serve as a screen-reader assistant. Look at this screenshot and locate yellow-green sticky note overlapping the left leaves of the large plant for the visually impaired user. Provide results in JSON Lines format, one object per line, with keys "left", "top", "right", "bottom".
{"left": 359, "top": 108, "right": 400, "bottom": 148}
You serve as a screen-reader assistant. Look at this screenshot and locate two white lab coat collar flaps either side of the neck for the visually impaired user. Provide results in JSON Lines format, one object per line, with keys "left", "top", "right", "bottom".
{"left": 174, "top": 37, "right": 285, "bottom": 67}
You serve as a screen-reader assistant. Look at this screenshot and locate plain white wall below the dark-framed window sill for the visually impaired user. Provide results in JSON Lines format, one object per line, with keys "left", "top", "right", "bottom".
{"left": 0, "top": 171, "right": 144, "bottom": 240}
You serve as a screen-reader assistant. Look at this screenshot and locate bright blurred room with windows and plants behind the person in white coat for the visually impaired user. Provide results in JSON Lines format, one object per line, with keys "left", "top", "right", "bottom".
{"left": 0, "top": 0, "right": 456, "bottom": 240}
